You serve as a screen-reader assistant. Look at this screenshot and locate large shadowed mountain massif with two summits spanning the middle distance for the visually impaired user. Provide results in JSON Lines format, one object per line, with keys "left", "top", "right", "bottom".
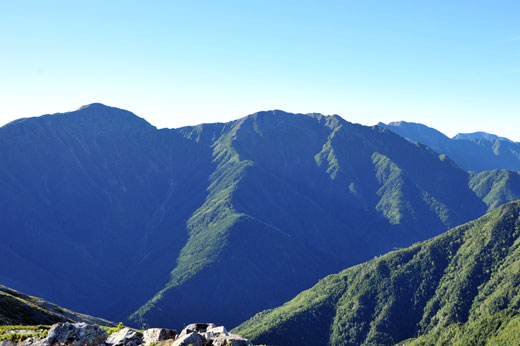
{"left": 0, "top": 104, "right": 520, "bottom": 328}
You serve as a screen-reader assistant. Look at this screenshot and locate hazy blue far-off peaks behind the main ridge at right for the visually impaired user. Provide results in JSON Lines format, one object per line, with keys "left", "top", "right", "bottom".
{"left": 379, "top": 121, "right": 520, "bottom": 173}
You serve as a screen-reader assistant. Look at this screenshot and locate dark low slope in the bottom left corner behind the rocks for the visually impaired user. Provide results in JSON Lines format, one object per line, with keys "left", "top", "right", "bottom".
{"left": 0, "top": 285, "right": 115, "bottom": 326}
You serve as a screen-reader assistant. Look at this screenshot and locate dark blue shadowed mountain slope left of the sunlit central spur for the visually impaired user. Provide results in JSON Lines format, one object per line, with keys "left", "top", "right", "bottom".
{"left": 0, "top": 104, "right": 212, "bottom": 320}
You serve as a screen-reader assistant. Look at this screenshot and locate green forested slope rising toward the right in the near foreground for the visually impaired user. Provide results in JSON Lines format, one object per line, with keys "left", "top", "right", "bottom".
{"left": 234, "top": 202, "right": 520, "bottom": 346}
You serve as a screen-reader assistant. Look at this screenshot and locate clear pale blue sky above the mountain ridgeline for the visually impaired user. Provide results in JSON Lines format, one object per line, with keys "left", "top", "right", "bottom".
{"left": 0, "top": 0, "right": 520, "bottom": 141}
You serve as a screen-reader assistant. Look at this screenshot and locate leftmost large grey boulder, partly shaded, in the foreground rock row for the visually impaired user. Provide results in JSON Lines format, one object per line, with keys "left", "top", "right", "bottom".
{"left": 45, "top": 322, "right": 108, "bottom": 346}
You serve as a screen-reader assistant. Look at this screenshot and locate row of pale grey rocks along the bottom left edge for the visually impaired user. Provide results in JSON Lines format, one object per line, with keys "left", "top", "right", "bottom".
{"left": 0, "top": 322, "right": 252, "bottom": 346}
